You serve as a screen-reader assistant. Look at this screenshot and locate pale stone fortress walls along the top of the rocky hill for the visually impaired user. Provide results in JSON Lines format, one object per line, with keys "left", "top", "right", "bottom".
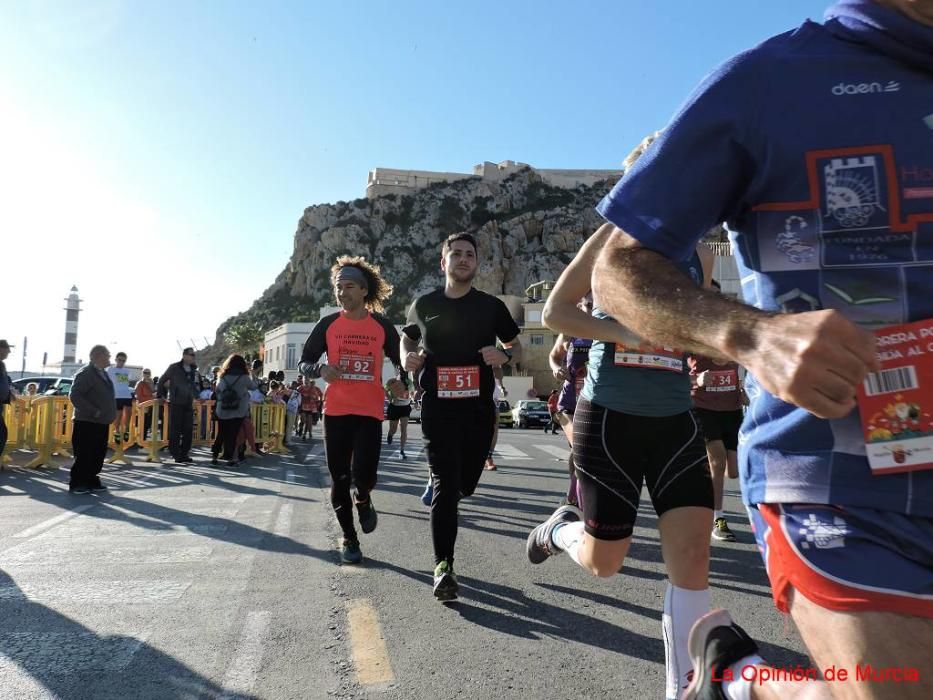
{"left": 366, "top": 160, "right": 622, "bottom": 199}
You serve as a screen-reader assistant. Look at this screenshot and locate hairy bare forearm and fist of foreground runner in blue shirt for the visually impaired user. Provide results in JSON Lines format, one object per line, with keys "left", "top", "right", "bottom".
{"left": 592, "top": 229, "right": 879, "bottom": 418}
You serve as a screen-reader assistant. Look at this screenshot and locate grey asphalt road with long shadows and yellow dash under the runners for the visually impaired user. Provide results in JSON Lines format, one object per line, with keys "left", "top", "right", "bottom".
{"left": 0, "top": 426, "right": 809, "bottom": 700}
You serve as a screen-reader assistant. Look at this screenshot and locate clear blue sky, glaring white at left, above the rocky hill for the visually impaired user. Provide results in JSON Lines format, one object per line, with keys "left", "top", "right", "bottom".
{"left": 0, "top": 0, "right": 827, "bottom": 372}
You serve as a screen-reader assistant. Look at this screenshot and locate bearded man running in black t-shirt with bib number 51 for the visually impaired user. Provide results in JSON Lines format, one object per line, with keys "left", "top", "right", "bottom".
{"left": 402, "top": 233, "right": 521, "bottom": 600}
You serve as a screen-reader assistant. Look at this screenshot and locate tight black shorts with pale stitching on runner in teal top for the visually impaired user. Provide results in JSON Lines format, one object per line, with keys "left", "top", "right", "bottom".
{"left": 573, "top": 398, "right": 713, "bottom": 540}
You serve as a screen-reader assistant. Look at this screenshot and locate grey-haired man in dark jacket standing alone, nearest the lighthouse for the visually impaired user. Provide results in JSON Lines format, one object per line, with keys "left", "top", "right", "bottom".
{"left": 68, "top": 345, "right": 117, "bottom": 494}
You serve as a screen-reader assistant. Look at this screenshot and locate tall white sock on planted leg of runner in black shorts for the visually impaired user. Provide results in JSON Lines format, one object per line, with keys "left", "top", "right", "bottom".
{"left": 661, "top": 583, "right": 710, "bottom": 698}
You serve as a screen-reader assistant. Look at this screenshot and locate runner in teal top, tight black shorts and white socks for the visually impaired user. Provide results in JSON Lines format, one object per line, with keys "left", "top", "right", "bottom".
{"left": 526, "top": 133, "right": 713, "bottom": 699}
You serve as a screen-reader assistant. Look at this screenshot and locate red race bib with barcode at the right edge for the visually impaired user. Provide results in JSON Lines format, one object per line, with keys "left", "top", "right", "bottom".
{"left": 858, "top": 319, "right": 933, "bottom": 474}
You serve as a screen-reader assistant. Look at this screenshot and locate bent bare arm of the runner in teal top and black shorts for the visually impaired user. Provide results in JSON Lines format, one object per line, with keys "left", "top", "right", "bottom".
{"left": 542, "top": 224, "right": 640, "bottom": 343}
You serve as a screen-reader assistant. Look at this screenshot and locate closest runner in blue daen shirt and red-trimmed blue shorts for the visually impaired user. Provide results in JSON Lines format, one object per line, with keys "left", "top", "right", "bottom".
{"left": 594, "top": 0, "right": 933, "bottom": 698}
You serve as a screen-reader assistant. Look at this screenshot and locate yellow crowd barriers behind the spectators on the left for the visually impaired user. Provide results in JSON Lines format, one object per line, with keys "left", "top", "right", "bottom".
{"left": 0, "top": 396, "right": 291, "bottom": 468}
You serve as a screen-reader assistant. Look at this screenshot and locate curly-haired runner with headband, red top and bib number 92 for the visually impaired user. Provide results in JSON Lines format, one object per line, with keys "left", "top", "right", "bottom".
{"left": 298, "top": 256, "right": 408, "bottom": 564}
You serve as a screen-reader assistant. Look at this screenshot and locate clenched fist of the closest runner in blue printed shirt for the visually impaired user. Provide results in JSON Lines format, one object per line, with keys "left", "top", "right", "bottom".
{"left": 736, "top": 310, "right": 881, "bottom": 418}
